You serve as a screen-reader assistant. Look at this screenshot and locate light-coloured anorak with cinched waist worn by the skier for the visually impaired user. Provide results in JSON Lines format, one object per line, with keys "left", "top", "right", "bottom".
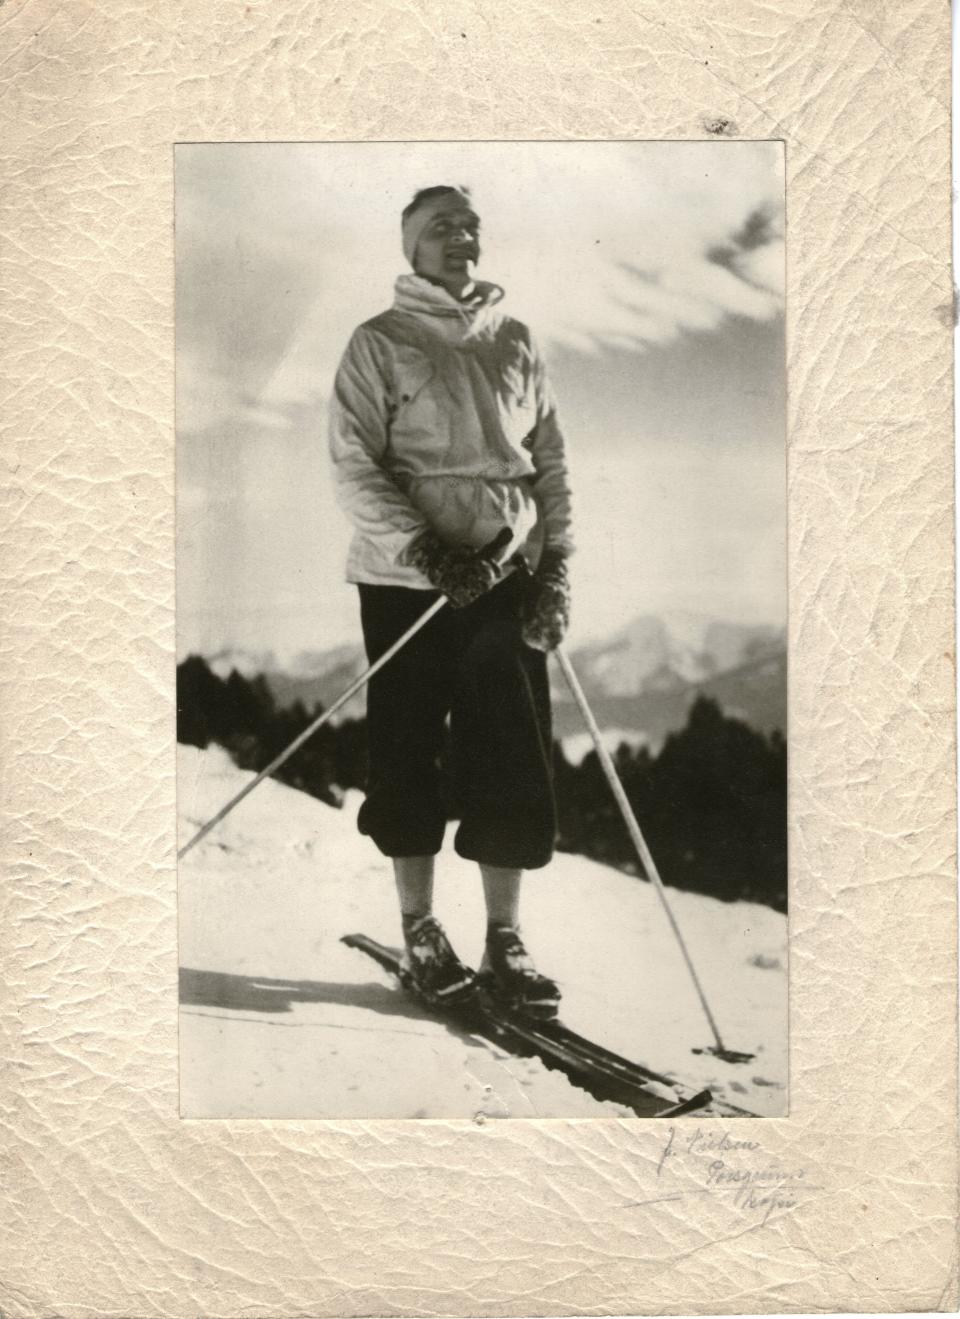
{"left": 330, "top": 274, "right": 572, "bottom": 588}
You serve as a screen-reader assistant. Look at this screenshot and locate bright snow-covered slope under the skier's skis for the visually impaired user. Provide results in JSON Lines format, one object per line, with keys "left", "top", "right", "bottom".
{"left": 178, "top": 747, "right": 787, "bottom": 1119}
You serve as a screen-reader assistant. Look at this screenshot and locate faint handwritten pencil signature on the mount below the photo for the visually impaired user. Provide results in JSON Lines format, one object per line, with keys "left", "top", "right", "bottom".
{"left": 624, "top": 1126, "right": 820, "bottom": 1227}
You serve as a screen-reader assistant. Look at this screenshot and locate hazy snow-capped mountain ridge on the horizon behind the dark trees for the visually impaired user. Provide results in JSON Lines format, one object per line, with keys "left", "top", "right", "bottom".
{"left": 206, "top": 611, "right": 787, "bottom": 745}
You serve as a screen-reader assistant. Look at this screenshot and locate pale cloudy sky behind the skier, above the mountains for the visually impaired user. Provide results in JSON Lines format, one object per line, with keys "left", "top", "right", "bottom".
{"left": 175, "top": 141, "right": 786, "bottom": 663}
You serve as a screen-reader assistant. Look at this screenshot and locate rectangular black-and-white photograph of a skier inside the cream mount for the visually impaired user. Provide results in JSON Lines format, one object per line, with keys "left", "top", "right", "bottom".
{"left": 175, "top": 140, "right": 789, "bottom": 1121}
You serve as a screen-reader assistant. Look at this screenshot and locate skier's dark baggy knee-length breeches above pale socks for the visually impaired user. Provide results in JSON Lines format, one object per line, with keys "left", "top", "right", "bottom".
{"left": 359, "top": 574, "right": 556, "bottom": 869}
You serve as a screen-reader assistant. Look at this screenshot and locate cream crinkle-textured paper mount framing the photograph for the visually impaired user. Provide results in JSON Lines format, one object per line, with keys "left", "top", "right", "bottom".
{"left": 0, "top": 0, "right": 957, "bottom": 1319}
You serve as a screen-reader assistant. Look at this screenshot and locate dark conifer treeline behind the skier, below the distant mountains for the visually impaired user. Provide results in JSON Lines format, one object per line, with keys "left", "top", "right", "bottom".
{"left": 177, "top": 656, "right": 787, "bottom": 911}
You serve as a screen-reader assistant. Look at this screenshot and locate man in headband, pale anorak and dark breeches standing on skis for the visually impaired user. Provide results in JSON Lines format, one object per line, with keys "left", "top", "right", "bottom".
{"left": 330, "top": 186, "right": 572, "bottom": 1016}
